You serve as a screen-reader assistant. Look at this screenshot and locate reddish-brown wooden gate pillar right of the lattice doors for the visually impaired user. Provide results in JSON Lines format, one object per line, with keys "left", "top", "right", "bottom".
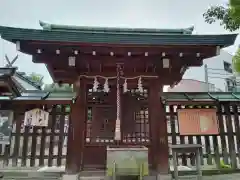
{"left": 149, "top": 79, "right": 168, "bottom": 174}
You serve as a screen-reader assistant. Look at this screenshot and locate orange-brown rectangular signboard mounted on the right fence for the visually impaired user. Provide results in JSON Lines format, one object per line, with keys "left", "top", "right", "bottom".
{"left": 178, "top": 109, "right": 219, "bottom": 135}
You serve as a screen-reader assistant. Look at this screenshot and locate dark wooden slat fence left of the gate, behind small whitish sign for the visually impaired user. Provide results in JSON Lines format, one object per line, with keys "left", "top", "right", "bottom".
{"left": 0, "top": 104, "right": 69, "bottom": 167}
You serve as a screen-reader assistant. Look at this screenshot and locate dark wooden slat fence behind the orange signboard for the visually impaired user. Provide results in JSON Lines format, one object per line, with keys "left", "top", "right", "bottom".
{"left": 166, "top": 102, "right": 240, "bottom": 168}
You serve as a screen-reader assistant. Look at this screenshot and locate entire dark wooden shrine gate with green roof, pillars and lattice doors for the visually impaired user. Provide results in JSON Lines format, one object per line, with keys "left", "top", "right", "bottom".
{"left": 0, "top": 22, "right": 236, "bottom": 177}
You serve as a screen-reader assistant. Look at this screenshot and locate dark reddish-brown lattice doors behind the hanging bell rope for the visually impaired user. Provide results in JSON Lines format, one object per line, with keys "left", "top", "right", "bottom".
{"left": 84, "top": 87, "right": 149, "bottom": 168}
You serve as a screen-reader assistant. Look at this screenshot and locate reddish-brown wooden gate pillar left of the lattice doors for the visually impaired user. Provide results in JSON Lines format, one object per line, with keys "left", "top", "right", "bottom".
{"left": 66, "top": 79, "right": 87, "bottom": 174}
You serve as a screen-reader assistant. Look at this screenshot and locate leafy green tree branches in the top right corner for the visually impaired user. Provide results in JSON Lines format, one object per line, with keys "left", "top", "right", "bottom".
{"left": 203, "top": 0, "right": 240, "bottom": 32}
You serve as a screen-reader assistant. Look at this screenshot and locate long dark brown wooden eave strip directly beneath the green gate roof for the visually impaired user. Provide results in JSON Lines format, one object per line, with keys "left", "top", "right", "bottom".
{"left": 25, "top": 41, "right": 216, "bottom": 57}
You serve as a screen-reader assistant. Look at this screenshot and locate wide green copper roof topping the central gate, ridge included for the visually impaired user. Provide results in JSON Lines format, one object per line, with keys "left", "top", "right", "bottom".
{"left": 0, "top": 22, "right": 237, "bottom": 47}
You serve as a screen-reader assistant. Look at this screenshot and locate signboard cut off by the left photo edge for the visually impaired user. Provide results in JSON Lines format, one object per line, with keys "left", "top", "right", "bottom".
{"left": 0, "top": 110, "right": 13, "bottom": 145}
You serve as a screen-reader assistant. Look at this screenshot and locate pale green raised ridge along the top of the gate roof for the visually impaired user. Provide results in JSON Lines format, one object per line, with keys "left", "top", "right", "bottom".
{"left": 39, "top": 21, "right": 194, "bottom": 35}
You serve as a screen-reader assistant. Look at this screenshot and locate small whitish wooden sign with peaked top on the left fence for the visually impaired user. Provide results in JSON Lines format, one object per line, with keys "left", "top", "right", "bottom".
{"left": 24, "top": 109, "right": 49, "bottom": 127}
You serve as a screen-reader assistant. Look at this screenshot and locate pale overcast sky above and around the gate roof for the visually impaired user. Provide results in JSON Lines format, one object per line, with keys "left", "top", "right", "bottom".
{"left": 0, "top": 0, "right": 240, "bottom": 83}
